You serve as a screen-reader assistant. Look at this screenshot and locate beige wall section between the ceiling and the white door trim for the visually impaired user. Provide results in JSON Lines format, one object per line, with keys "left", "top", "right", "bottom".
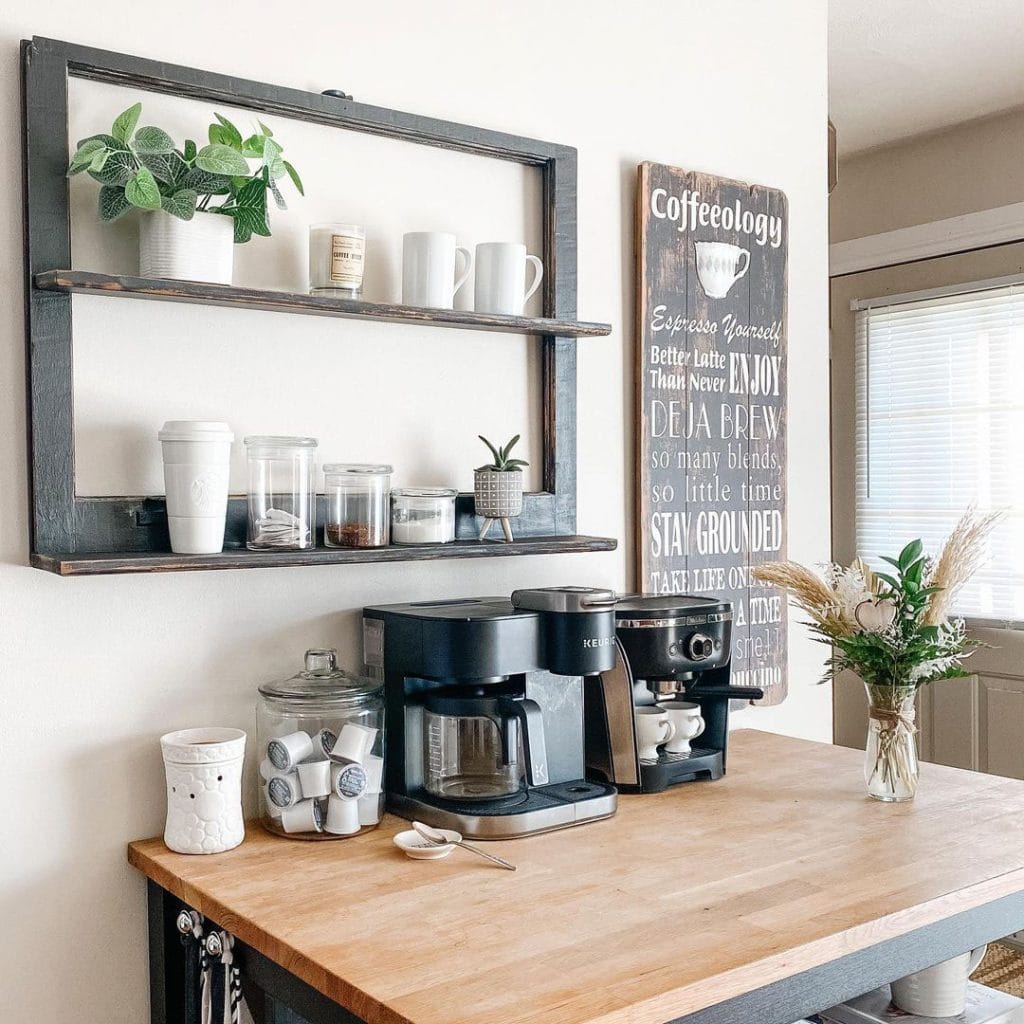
{"left": 829, "top": 108, "right": 1024, "bottom": 242}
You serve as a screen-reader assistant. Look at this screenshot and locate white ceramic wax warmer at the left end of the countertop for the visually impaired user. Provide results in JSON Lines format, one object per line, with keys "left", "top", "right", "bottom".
{"left": 160, "top": 728, "right": 246, "bottom": 853}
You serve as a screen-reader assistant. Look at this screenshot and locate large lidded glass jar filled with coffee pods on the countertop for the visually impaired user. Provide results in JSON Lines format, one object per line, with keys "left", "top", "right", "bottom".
{"left": 256, "top": 649, "right": 384, "bottom": 840}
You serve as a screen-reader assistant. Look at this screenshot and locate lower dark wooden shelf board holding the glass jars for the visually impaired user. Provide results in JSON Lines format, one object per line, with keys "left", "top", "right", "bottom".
{"left": 31, "top": 536, "right": 618, "bottom": 577}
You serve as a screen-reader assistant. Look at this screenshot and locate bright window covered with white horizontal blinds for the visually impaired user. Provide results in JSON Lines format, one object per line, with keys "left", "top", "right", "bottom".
{"left": 854, "top": 282, "right": 1024, "bottom": 628}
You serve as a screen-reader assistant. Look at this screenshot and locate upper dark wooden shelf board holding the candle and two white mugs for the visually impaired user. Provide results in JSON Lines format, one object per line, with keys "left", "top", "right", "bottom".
{"left": 36, "top": 270, "right": 611, "bottom": 338}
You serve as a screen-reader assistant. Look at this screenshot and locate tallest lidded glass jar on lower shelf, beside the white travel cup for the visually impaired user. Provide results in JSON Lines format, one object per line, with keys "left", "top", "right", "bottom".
{"left": 245, "top": 435, "right": 316, "bottom": 551}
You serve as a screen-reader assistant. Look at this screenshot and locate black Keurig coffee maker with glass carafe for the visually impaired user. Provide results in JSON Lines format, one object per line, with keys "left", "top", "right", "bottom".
{"left": 362, "top": 587, "right": 615, "bottom": 839}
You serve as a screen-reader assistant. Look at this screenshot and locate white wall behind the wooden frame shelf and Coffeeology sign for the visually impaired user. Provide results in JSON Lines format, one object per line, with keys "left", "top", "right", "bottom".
{"left": 0, "top": 0, "right": 828, "bottom": 1024}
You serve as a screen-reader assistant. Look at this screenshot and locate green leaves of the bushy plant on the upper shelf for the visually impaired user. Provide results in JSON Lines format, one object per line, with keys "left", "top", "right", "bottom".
{"left": 68, "top": 103, "right": 305, "bottom": 243}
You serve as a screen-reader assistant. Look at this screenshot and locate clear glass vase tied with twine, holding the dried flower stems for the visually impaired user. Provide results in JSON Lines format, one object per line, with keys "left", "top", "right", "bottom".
{"left": 864, "top": 683, "right": 920, "bottom": 804}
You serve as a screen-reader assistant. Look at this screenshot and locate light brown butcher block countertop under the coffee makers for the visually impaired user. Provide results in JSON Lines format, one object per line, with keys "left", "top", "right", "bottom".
{"left": 128, "top": 730, "right": 1024, "bottom": 1024}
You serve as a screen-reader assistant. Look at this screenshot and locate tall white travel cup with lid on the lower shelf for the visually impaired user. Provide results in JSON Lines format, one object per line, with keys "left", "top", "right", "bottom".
{"left": 157, "top": 420, "right": 234, "bottom": 555}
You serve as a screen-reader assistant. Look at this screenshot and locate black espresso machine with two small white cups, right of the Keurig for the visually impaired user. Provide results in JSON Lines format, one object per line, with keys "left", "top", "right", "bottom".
{"left": 584, "top": 595, "right": 764, "bottom": 793}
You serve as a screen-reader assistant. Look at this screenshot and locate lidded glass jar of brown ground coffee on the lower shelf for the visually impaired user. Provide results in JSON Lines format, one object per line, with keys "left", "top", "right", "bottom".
{"left": 324, "top": 462, "right": 391, "bottom": 548}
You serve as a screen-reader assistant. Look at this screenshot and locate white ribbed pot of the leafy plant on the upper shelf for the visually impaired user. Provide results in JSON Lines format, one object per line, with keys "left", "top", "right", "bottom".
{"left": 138, "top": 210, "right": 234, "bottom": 285}
